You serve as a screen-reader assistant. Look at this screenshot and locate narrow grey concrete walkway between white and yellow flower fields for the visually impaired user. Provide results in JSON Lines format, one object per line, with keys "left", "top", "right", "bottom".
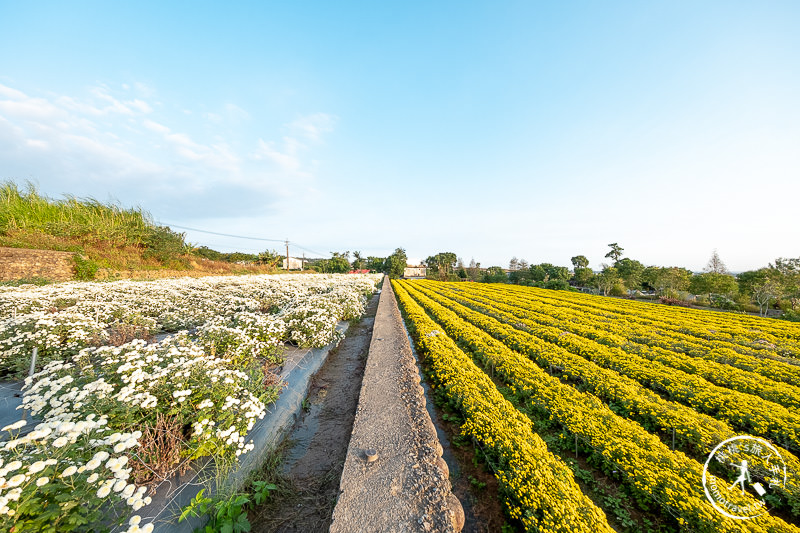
{"left": 330, "top": 279, "right": 463, "bottom": 533}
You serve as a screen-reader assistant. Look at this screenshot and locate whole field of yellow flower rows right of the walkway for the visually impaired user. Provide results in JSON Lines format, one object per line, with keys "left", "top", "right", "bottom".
{"left": 393, "top": 280, "right": 800, "bottom": 531}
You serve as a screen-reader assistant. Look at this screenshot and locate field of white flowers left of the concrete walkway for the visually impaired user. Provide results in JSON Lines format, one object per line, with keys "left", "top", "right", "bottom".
{"left": 0, "top": 275, "right": 380, "bottom": 532}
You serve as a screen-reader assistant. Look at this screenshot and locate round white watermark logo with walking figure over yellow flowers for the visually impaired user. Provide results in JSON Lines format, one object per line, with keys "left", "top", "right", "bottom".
{"left": 703, "top": 435, "right": 786, "bottom": 520}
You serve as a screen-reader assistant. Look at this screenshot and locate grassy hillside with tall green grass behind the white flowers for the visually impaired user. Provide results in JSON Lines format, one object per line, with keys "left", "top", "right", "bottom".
{"left": 0, "top": 181, "right": 275, "bottom": 279}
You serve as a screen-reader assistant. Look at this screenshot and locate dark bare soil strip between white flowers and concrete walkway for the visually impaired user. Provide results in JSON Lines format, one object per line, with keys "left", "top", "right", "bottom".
{"left": 249, "top": 294, "right": 380, "bottom": 533}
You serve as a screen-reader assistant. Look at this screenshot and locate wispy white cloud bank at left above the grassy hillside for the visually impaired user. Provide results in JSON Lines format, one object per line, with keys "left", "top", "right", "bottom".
{"left": 0, "top": 83, "right": 334, "bottom": 214}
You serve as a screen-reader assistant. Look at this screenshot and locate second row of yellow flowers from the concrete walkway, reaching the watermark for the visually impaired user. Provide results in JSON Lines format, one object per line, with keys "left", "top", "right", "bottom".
{"left": 404, "top": 284, "right": 800, "bottom": 531}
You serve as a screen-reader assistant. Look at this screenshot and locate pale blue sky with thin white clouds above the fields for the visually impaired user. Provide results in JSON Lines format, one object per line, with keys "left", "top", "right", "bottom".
{"left": 0, "top": 0, "right": 800, "bottom": 270}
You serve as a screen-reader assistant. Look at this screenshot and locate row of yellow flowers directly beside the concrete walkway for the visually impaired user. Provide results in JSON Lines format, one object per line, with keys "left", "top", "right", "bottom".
{"left": 392, "top": 282, "right": 613, "bottom": 533}
